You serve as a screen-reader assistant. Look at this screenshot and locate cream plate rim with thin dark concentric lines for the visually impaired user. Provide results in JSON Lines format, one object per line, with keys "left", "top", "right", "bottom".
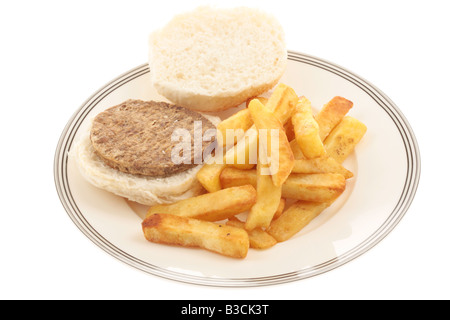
{"left": 53, "top": 50, "right": 421, "bottom": 287}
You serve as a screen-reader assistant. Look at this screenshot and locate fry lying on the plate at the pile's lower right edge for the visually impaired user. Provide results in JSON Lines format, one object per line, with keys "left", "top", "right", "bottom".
{"left": 267, "top": 201, "right": 329, "bottom": 242}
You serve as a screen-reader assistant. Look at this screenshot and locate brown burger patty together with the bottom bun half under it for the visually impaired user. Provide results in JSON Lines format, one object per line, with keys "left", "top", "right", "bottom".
{"left": 74, "top": 100, "right": 218, "bottom": 205}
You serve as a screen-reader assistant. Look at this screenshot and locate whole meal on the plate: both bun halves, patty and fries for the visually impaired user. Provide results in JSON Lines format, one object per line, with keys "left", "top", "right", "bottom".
{"left": 68, "top": 7, "right": 367, "bottom": 259}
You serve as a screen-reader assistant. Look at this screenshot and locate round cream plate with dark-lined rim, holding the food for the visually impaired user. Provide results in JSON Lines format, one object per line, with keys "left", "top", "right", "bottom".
{"left": 54, "top": 52, "right": 420, "bottom": 286}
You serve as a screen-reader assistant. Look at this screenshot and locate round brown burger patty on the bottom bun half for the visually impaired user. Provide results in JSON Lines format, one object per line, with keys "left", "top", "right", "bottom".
{"left": 91, "top": 100, "right": 216, "bottom": 177}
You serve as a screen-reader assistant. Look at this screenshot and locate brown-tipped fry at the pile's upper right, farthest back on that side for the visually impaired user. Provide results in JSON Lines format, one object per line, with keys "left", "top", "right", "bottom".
{"left": 316, "top": 96, "right": 353, "bottom": 141}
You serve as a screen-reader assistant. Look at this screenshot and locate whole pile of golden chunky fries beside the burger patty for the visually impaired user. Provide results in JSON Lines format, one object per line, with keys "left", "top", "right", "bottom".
{"left": 142, "top": 83, "right": 367, "bottom": 259}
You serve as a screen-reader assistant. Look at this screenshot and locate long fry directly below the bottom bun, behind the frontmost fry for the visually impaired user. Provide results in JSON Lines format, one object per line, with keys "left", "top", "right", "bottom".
{"left": 147, "top": 185, "right": 256, "bottom": 221}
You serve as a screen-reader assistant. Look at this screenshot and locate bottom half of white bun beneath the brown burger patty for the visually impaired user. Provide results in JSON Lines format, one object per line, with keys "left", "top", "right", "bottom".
{"left": 73, "top": 134, "right": 205, "bottom": 206}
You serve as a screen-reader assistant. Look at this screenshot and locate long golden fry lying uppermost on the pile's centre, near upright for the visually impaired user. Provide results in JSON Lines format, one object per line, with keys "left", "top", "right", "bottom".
{"left": 248, "top": 98, "right": 294, "bottom": 187}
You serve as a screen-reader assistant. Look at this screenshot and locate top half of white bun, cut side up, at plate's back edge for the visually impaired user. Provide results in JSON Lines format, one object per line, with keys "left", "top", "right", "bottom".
{"left": 149, "top": 7, "right": 287, "bottom": 112}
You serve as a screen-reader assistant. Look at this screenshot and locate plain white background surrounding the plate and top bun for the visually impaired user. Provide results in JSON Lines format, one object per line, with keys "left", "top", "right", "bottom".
{"left": 0, "top": 0, "right": 450, "bottom": 299}
